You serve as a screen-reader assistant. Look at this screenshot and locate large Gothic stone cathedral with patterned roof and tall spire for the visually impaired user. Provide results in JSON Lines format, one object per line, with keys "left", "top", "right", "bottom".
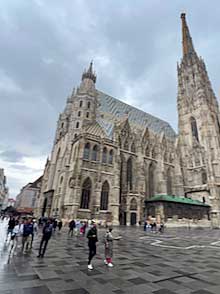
{"left": 36, "top": 13, "right": 220, "bottom": 227}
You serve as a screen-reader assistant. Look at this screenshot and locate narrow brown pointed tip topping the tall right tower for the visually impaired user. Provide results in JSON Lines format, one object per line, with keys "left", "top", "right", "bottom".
{"left": 181, "top": 13, "right": 196, "bottom": 57}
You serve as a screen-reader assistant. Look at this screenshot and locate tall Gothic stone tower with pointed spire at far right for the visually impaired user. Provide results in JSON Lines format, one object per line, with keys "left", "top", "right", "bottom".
{"left": 177, "top": 13, "right": 220, "bottom": 226}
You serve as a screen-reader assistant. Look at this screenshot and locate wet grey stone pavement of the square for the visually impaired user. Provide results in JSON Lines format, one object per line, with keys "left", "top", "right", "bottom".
{"left": 0, "top": 223, "right": 220, "bottom": 294}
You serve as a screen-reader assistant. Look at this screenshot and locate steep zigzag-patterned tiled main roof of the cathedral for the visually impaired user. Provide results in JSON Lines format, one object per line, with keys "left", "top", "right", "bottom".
{"left": 97, "top": 91, "right": 176, "bottom": 139}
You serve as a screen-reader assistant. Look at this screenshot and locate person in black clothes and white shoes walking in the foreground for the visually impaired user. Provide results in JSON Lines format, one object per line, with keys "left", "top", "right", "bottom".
{"left": 87, "top": 220, "right": 98, "bottom": 270}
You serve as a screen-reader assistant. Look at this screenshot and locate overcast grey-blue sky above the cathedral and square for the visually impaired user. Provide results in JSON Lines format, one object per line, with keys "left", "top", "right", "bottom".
{"left": 0, "top": 0, "right": 220, "bottom": 197}
